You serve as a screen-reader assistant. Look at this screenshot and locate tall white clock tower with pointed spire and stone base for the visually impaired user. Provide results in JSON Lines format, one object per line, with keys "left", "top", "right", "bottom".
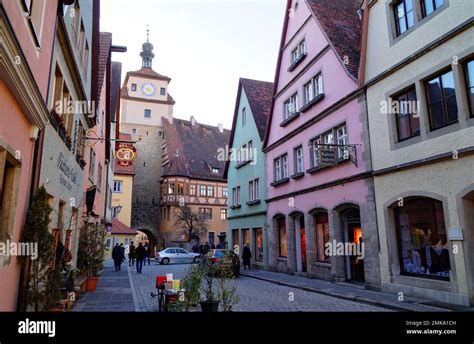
{"left": 120, "top": 30, "right": 175, "bottom": 250}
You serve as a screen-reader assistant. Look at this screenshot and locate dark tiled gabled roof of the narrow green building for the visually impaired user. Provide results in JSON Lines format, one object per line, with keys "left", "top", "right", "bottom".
{"left": 224, "top": 78, "right": 274, "bottom": 179}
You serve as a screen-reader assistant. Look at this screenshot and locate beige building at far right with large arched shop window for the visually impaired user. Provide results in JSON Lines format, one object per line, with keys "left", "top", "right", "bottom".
{"left": 363, "top": 0, "right": 474, "bottom": 305}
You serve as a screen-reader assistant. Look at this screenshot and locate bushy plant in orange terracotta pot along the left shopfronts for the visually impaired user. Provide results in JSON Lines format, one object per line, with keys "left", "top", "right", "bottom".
{"left": 77, "top": 219, "right": 105, "bottom": 291}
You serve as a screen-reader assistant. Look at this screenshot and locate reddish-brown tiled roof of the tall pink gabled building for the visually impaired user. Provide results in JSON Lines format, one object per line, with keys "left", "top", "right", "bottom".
{"left": 307, "top": 0, "right": 363, "bottom": 80}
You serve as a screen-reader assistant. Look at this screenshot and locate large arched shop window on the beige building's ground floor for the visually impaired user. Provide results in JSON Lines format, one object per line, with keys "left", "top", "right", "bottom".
{"left": 396, "top": 198, "right": 451, "bottom": 280}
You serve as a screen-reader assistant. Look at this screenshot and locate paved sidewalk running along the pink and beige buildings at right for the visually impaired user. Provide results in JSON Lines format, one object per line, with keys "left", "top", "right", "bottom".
{"left": 241, "top": 269, "right": 468, "bottom": 312}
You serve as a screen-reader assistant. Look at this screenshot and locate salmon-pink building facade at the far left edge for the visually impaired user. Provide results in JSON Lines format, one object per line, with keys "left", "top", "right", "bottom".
{"left": 0, "top": 0, "right": 58, "bottom": 311}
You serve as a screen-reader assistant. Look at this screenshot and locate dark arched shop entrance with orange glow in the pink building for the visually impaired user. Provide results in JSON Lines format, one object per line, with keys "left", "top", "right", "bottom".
{"left": 343, "top": 209, "right": 365, "bottom": 283}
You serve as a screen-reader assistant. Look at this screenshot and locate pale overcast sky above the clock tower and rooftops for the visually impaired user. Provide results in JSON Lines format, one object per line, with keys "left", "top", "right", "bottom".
{"left": 101, "top": 0, "right": 286, "bottom": 129}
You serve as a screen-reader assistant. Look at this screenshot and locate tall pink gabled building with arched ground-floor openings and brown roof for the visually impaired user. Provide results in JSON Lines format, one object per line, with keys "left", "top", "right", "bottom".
{"left": 263, "top": 0, "right": 380, "bottom": 289}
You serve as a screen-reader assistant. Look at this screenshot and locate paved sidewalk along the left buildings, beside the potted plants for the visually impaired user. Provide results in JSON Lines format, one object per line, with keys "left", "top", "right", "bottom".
{"left": 73, "top": 260, "right": 136, "bottom": 312}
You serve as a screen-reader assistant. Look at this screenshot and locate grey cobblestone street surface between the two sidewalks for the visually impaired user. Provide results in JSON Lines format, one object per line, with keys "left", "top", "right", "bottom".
{"left": 130, "top": 262, "right": 387, "bottom": 312}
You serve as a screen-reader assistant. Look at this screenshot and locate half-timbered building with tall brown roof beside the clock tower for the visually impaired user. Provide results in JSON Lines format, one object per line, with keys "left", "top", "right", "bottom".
{"left": 160, "top": 118, "right": 230, "bottom": 249}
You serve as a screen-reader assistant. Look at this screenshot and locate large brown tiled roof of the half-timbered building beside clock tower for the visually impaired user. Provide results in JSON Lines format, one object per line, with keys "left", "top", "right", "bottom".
{"left": 163, "top": 118, "right": 230, "bottom": 181}
